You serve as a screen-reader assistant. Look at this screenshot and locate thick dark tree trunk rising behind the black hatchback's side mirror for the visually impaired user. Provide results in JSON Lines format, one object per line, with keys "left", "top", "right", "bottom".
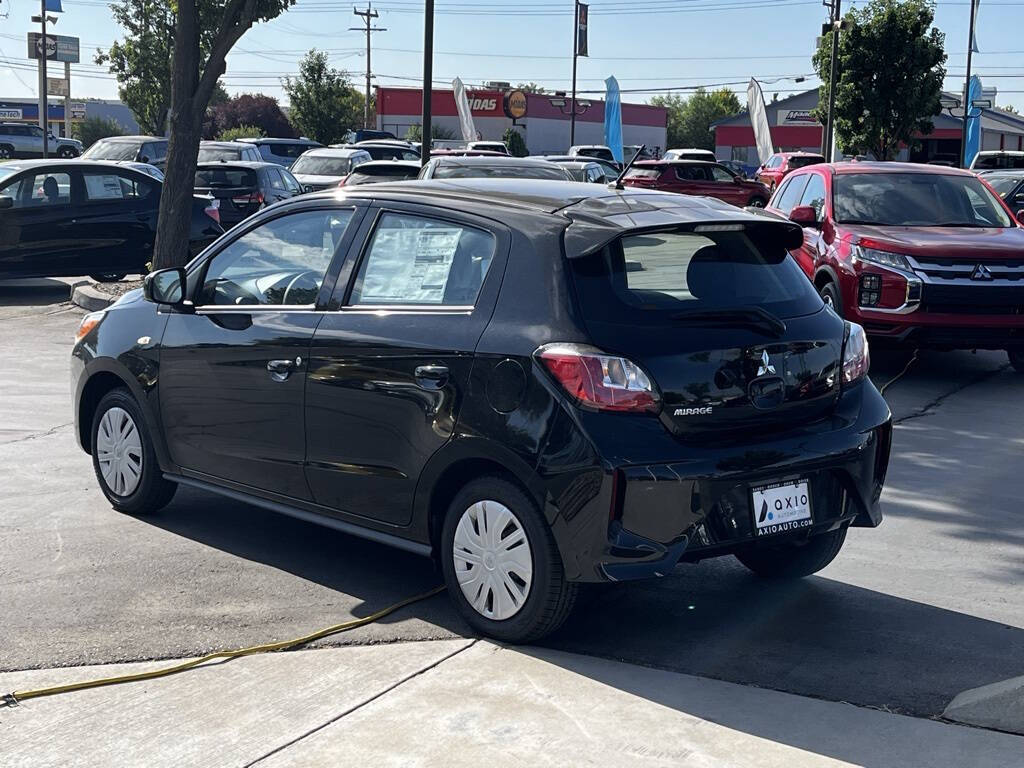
{"left": 151, "top": 0, "right": 294, "bottom": 269}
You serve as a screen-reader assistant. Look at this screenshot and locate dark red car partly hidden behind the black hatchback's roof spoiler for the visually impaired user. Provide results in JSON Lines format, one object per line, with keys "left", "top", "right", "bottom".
{"left": 623, "top": 160, "right": 771, "bottom": 208}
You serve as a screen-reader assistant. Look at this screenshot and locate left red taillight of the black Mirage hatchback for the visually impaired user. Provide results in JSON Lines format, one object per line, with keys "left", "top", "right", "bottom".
{"left": 536, "top": 344, "right": 662, "bottom": 413}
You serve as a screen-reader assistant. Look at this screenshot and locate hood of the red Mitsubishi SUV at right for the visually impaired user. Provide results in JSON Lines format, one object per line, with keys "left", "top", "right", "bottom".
{"left": 840, "top": 224, "right": 1024, "bottom": 259}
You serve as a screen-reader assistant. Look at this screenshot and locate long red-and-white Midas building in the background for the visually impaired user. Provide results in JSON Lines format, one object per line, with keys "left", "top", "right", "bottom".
{"left": 377, "top": 84, "right": 669, "bottom": 155}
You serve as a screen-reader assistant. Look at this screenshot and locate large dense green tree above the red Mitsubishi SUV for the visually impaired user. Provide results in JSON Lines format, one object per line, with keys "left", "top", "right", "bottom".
{"left": 812, "top": 0, "right": 946, "bottom": 160}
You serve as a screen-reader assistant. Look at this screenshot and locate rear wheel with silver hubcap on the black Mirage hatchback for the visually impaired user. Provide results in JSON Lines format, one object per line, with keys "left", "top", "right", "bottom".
{"left": 440, "top": 476, "right": 578, "bottom": 643}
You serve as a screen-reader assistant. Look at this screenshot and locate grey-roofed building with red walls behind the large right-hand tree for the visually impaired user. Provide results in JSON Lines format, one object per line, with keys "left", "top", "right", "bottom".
{"left": 713, "top": 88, "right": 1024, "bottom": 168}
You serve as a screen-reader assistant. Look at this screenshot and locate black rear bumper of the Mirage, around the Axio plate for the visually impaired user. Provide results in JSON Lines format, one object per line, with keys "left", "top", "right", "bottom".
{"left": 553, "top": 383, "right": 892, "bottom": 582}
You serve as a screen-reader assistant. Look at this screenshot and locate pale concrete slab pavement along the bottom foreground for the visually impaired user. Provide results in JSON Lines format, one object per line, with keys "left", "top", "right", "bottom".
{"left": 0, "top": 639, "right": 1024, "bottom": 768}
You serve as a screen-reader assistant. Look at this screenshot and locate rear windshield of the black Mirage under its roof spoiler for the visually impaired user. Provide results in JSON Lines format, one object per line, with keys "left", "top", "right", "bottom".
{"left": 571, "top": 231, "right": 821, "bottom": 325}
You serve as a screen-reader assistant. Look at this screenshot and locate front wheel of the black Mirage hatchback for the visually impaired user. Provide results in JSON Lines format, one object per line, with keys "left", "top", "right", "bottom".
{"left": 90, "top": 388, "right": 178, "bottom": 515}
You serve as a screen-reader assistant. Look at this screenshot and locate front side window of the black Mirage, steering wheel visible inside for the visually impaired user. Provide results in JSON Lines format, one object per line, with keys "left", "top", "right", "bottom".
{"left": 199, "top": 209, "right": 352, "bottom": 306}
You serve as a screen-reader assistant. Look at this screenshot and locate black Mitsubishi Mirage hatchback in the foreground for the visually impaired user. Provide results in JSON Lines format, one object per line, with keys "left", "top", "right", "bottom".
{"left": 72, "top": 179, "right": 891, "bottom": 642}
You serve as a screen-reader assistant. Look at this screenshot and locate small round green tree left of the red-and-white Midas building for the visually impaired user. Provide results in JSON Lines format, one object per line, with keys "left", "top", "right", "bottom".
{"left": 284, "top": 48, "right": 364, "bottom": 144}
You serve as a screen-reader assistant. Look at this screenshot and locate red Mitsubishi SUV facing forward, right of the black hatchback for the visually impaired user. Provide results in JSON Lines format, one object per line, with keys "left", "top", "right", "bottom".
{"left": 769, "top": 163, "right": 1024, "bottom": 371}
